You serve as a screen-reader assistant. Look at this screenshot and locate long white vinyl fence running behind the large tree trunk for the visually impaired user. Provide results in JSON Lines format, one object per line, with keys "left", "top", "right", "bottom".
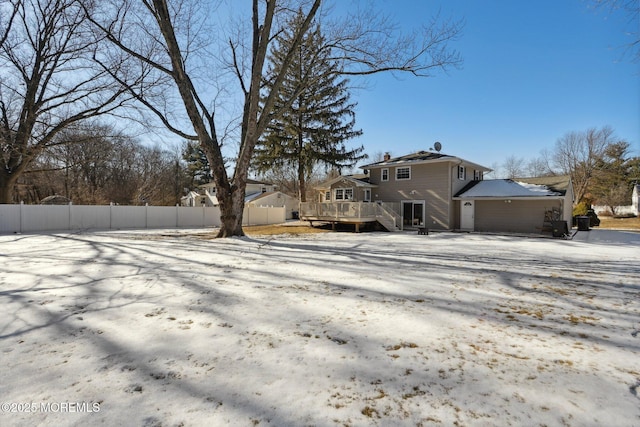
{"left": 0, "top": 204, "right": 286, "bottom": 234}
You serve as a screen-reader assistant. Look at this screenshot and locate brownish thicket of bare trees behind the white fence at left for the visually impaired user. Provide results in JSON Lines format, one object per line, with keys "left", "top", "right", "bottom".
{"left": 25, "top": 123, "right": 186, "bottom": 205}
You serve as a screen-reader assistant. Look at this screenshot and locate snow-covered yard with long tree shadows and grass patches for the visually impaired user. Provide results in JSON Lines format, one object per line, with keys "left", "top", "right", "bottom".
{"left": 0, "top": 230, "right": 640, "bottom": 427}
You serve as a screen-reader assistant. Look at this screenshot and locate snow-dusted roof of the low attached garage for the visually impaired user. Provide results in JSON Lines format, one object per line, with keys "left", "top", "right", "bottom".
{"left": 456, "top": 179, "right": 562, "bottom": 199}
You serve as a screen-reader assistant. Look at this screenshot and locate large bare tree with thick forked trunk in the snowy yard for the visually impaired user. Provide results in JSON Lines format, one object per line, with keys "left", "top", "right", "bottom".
{"left": 93, "top": 0, "right": 460, "bottom": 237}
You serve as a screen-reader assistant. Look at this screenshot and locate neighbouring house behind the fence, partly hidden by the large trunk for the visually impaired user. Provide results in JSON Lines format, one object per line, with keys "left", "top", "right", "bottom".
{"left": 181, "top": 179, "right": 298, "bottom": 219}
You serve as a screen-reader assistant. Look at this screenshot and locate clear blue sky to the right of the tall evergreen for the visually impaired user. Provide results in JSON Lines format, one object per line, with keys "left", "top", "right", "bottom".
{"left": 351, "top": 0, "right": 640, "bottom": 172}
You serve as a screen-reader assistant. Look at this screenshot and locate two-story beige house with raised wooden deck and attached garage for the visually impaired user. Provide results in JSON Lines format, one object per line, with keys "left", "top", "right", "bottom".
{"left": 300, "top": 151, "right": 573, "bottom": 233}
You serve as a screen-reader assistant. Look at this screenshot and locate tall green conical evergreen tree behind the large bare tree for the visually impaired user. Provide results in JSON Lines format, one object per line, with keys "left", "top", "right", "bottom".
{"left": 254, "top": 12, "right": 367, "bottom": 202}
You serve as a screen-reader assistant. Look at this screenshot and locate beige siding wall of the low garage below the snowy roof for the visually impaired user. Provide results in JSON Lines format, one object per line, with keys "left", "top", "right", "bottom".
{"left": 474, "top": 199, "right": 560, "bottom": 234}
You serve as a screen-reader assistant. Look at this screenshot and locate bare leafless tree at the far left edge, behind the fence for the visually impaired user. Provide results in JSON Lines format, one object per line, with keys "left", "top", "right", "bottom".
{"left": 0, "top": 0, "right": 130, "bottom": 203}
